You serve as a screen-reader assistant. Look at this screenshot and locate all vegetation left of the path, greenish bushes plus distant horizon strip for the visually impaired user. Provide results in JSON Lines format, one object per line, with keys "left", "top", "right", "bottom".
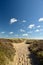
{"left": 0, "top": 38, "right": 25, "bottom": 65}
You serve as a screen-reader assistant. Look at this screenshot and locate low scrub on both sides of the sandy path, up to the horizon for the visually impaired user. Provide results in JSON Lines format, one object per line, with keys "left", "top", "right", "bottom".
{"left": 0, "top": 38, "right": 43, "bottom": 65}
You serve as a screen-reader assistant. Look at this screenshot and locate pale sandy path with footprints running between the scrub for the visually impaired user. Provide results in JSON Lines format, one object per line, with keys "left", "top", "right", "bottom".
{"left": 13, "top": 43, "right": 31, "bottom": 65}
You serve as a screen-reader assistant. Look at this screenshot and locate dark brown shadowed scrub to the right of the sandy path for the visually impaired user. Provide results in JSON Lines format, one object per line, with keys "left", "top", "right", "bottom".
{"left": 26, "top": 40, "right": 43, "bottom": 65}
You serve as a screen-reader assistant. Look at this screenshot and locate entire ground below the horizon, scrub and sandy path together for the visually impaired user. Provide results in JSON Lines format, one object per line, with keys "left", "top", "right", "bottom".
{"left": 0, "top": 38, "right": 43, "bottom": 65}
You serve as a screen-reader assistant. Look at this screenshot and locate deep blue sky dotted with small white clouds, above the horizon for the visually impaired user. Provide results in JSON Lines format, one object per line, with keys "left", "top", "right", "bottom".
{"left": 0, "top": 0, "right": 43, "bottom": 38}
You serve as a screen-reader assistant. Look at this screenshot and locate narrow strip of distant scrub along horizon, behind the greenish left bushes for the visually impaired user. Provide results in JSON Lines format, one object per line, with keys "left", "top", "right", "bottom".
{"left": 0, "top": 38, "right": 25, "bottom": 43}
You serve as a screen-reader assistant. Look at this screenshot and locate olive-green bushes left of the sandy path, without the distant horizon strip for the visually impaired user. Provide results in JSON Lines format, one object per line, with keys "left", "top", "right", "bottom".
{"left": 0, "top": 42, "right": 15, "bottom": 65}
